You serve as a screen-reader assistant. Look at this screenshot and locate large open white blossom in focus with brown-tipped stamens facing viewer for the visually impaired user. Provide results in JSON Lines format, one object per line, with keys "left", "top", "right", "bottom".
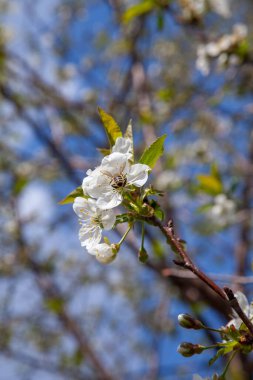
{"left": 82, "top": 152, "right": 150, "bottom": 210}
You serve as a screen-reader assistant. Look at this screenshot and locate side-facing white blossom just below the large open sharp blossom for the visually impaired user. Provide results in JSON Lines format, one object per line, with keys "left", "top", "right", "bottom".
{"left": 73, "top": 197, "right": 116, "bottom": 248}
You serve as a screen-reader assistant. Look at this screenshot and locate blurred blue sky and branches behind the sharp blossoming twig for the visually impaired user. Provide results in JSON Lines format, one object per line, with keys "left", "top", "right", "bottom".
{"left": 0, "top": 0, "right": 253, "bottom": 380}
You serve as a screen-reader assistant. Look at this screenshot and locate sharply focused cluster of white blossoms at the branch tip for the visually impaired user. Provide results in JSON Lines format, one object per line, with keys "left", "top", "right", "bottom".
{"left": 73, "top": 137, "right": 150, "bottom": 263}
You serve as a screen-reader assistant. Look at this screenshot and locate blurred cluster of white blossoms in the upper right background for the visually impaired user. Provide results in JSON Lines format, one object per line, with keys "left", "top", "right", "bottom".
{"left": 196, "top": 24, "right": 248, "bottom": 75}
